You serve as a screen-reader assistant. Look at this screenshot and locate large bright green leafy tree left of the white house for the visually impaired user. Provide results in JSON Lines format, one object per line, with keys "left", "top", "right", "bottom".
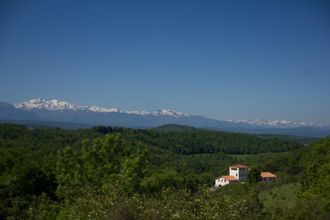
{"left": 56, "top": 134, "right": 148, "bottom": 201}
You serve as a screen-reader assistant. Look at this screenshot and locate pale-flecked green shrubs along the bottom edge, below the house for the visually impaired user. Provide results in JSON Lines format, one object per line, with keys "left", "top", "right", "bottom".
{"left": 55, "top": 185, "right": 261, "bottom": 219}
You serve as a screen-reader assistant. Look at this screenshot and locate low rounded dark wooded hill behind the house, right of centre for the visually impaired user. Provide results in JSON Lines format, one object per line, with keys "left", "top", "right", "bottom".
{"left": 135, "top": 125, "right": 302, "bottom": 154}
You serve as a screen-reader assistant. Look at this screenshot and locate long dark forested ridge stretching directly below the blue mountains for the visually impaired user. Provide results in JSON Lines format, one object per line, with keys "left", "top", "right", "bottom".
{"left": 0, "top": 124, "right": 302, "bottom": 154}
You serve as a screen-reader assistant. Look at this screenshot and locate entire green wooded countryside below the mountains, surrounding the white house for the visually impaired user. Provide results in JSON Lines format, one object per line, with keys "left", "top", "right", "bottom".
{"left": 0, "top": 124, "right": 330, "bottom": 219}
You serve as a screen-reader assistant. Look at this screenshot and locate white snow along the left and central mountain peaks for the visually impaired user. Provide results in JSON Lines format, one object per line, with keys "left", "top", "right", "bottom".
{"left": 15, "top": 98, "right": 189, "bottom": 117}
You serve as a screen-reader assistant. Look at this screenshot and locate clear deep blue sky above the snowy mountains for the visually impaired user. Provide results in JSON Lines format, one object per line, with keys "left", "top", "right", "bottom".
{"left": 0, "top": 0, "right": 330, "bottom": 123}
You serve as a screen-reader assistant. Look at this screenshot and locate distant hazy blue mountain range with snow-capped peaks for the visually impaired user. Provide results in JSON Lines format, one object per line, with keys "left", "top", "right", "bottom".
{"left": 0, "top": 98, "right": 330, "bottom": 137}
